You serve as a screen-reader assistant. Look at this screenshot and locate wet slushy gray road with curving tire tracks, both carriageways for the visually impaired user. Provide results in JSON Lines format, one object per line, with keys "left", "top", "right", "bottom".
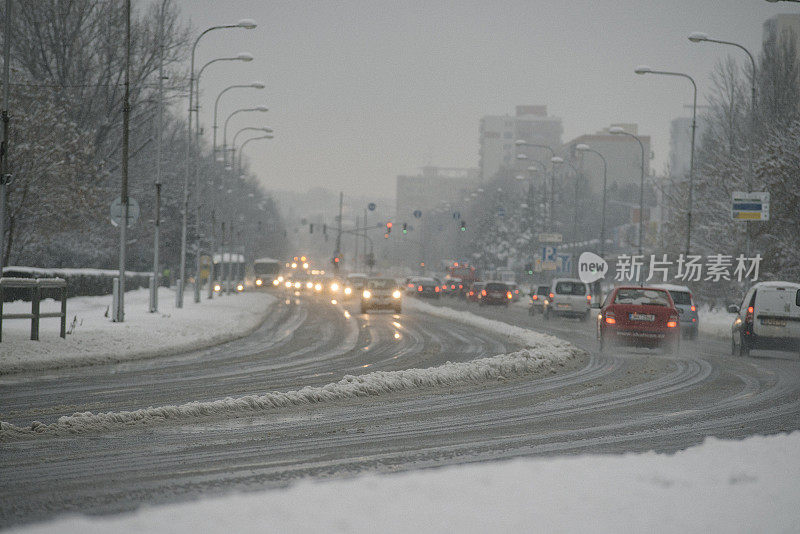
{"left": 0, "top": 299, "right": 800, "bottom": 525}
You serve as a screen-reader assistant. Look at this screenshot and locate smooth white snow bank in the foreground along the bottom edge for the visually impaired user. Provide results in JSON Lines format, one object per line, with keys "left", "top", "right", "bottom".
{"left": 9, "top": 432, "right": 800, "bottom": 534}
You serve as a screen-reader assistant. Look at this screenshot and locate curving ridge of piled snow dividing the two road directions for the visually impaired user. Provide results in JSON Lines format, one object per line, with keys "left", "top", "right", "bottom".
{"left": 0, "top": 303, "right": 580, "bottom": 441}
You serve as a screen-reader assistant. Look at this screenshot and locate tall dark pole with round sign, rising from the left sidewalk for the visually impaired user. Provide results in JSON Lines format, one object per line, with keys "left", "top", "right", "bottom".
{"left": 113, "top": 0, "right": 131, "bottom": 323}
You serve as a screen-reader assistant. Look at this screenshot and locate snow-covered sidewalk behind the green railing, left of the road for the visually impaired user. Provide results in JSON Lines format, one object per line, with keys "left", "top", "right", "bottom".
{"left": 0, "top": 288, "right": 275, "bottom": 374}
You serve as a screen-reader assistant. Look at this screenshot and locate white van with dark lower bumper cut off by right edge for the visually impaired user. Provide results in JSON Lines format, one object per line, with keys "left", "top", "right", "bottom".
{"left": 728, "top": 282, "right": 800, "bottom": 356}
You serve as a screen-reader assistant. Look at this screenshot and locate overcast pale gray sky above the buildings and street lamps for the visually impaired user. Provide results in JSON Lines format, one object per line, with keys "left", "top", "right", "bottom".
{"left": 173, "top": 0, "right": 788, "bottom": 197}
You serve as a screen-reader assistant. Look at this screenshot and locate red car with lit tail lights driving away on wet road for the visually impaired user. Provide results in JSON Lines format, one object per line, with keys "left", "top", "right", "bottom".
{"left": 597, "top": 286, "right": 681, "bottom": 354}
